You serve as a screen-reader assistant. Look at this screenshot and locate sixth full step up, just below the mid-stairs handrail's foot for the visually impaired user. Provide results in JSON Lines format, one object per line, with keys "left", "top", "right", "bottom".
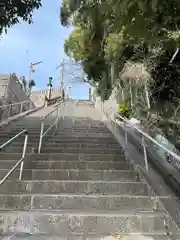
{"left": 0, "top": 152, "right": 126, "bottom": 162}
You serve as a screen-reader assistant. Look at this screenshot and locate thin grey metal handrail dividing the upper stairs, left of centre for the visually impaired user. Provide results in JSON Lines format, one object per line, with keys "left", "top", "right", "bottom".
{"left": 38, "top": 100, "right": 66, "bottom": 153}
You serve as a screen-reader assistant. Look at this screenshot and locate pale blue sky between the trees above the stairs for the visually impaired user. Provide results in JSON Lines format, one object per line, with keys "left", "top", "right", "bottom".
{"left": 0, "top": 0, "right": 88, "bottom": 98}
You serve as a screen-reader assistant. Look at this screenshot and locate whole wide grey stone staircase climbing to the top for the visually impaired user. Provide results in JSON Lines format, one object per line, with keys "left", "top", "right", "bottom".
{"left": 0, "top": 103, "right": 180, "bottom": 240}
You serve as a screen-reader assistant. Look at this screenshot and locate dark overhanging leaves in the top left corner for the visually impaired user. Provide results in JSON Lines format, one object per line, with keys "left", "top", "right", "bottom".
{"left": 0, "top": 0, "right": 41, "bottom": 35}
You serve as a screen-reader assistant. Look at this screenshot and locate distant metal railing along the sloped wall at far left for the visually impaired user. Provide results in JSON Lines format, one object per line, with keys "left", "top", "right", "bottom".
{"left": 0, "top": 100, "right": 33, "bottom": 121}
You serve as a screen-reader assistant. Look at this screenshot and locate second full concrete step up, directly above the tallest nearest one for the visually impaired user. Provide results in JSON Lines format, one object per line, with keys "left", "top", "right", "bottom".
{"left": 0, "top": 194, "right": 160, "bottom": 214}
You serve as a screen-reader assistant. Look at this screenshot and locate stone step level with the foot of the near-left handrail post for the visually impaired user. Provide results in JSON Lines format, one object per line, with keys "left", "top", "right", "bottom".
{"left": 29, "top": 169, "right": 137, "bottom": 181}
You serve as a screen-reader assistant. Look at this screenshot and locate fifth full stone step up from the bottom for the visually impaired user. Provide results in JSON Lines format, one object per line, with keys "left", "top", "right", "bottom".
{"left": 26, "top": 160, "right": 133, "bottom": 170}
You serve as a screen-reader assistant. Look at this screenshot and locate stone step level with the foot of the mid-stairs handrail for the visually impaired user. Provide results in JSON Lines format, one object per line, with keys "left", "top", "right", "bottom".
{"left": 42, "top": 145, "right": 123, "bottom": 154}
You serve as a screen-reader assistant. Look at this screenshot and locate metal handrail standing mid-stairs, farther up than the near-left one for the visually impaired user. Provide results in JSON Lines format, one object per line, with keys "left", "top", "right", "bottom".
{"left": 38, "top": 100, "right": 66, "bottom": 153}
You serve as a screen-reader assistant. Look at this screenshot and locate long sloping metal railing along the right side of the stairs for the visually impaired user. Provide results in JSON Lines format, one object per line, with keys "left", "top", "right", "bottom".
{"left": 101, "top": 106, "right": 180, "bottom": 172}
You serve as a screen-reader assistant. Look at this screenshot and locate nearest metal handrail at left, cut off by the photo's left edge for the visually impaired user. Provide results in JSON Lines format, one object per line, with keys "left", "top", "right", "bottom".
{"left": 0, "top": 129, "right": 28, "bottom": 186}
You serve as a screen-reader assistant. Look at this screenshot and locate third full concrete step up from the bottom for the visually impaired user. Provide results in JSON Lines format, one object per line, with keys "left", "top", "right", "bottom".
{"left": 0, "top": 181, "right": 150, "bottom": 196}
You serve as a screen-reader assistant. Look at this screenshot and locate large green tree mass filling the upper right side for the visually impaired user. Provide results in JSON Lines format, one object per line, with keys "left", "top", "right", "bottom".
{"left": 60, "top": 0, "right": 180, "bottom": 147}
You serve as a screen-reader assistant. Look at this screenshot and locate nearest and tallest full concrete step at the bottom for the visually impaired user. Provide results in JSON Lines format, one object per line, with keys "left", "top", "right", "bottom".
{"left": 0, "top": 212, "right": 177, "bottom": 235}
